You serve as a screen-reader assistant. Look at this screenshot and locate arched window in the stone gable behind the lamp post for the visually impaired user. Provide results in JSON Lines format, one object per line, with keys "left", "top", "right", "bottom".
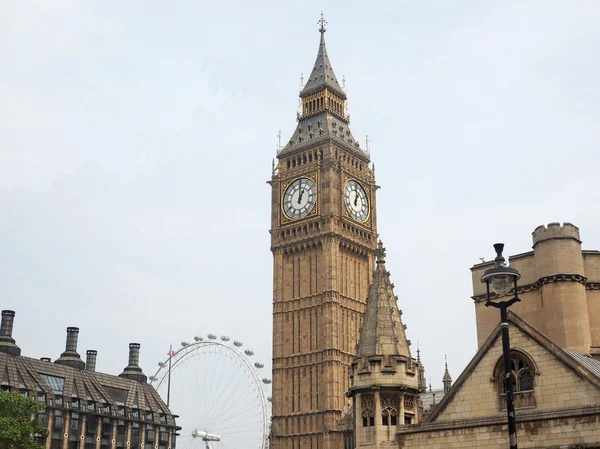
{"left": 494, "top": 350, "right": 539, "bottom": 409}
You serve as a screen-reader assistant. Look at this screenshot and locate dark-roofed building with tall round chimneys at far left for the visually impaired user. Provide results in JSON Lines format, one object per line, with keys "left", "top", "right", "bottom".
{"left": 0, "top": 310, "right": 179, "bottom": 449}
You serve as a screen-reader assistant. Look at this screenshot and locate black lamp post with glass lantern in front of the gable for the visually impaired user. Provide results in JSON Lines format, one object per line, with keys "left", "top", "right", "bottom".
{"left": 481, "top": 243, "right": 521, "bottom": 449}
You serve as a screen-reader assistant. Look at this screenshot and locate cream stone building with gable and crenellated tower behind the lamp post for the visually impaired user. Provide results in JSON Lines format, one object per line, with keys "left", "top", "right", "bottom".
{"left": 397, "top": 223, "right": 600, "bottom": 449}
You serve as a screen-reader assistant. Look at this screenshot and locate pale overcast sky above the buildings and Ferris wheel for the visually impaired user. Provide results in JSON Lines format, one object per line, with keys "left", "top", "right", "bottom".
{"left": 0, "top": 0, "right": 600, "bottom": 406}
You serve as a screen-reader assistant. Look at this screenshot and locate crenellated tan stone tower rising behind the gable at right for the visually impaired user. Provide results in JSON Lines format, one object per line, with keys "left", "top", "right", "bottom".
{"left": 471, "top": 223, "right": 600, "bottom": 358}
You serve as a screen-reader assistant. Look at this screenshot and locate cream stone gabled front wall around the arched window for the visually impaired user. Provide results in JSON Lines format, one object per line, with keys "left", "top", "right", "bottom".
{"left": 397, "top": 312, "right": 600, "bottom": 449}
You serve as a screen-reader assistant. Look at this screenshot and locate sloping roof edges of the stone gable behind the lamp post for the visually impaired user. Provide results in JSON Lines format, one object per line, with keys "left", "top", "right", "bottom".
{"left": 424, "top": 311, "right": 600, "bottom": 422}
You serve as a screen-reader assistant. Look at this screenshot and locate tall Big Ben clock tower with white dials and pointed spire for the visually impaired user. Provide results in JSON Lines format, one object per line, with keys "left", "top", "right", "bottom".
{"left": 270, "top": 16, "right": 377, "bottom": 449}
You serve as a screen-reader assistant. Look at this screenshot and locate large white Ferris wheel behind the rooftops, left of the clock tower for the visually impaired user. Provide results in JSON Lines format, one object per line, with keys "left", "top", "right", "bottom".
{"left": 149, "top": 334, "right": 271, "bottom": 449}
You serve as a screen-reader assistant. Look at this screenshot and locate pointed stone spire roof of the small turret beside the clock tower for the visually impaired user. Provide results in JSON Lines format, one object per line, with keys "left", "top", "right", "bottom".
{"left": 357, "top": 240, "right": 412, "bottom": 363}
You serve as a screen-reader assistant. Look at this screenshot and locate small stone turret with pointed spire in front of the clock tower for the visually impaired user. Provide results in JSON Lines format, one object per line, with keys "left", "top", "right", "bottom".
{"left": 349, "top": 241, "right": 420, "bottom": 448}
